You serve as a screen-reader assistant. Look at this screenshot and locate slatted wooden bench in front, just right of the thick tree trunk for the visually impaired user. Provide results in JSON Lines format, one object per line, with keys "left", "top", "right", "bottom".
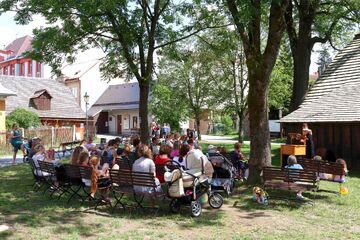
{"left": 263, "top": 167, "right": 318, "bottom": 204}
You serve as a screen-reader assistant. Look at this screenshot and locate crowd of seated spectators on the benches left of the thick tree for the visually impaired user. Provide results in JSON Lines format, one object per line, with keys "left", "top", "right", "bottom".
{"left": 26, "top": 128, "right": 250, "bottom": 201}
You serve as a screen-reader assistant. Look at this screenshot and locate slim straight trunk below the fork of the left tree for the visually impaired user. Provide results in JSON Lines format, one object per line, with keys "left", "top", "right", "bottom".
{"left": 139, "top": 81, "right": 150, "bottom": 143}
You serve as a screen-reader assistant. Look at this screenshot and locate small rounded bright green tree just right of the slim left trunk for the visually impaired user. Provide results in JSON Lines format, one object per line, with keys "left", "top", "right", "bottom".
{"left": 150, "top": 81, "right": 189, "bottom": 130}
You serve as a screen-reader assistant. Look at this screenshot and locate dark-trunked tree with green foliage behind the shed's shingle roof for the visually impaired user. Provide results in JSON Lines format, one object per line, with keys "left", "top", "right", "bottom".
{"left": 285, "top": 0, "right": 360, "bottom": 111}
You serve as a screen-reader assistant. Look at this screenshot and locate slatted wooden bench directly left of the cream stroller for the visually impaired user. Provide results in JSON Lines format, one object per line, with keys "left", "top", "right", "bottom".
{"left": 109, "top": 169, "right": 165, "bottom": 210}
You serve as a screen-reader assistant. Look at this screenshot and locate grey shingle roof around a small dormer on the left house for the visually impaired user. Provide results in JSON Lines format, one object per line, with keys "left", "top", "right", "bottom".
{"left": 0, "top": 76, "right": 86, "bottom": 119}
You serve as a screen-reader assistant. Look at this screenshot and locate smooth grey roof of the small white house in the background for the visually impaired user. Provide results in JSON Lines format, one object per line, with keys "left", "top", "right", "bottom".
{"left": 89, "top": 82, "right": 140, "bottom": 115}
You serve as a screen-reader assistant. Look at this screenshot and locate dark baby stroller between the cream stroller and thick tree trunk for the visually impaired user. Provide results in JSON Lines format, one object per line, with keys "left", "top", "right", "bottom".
{"left": 207, "top": 152, "right": 237, "bottom": 196}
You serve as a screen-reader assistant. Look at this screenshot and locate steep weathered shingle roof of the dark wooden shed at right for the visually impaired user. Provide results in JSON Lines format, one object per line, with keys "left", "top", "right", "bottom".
{"left": 280, "top": 34, "right": 360, "bottom": 122}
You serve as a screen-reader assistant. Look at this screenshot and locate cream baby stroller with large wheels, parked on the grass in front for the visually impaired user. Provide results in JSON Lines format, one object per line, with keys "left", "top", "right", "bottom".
{"left": 164, "top": 161, "right": 224, "bottom": 217}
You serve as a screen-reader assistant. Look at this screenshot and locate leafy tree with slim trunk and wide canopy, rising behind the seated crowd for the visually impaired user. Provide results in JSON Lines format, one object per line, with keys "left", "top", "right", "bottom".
{"left": 0, "top": 0, "right": 217, "bottom": 142}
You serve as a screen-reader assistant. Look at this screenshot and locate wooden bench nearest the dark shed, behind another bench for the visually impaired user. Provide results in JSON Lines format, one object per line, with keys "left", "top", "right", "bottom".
{"left": 298, "top": 159, "right": 344, "bottom": 192}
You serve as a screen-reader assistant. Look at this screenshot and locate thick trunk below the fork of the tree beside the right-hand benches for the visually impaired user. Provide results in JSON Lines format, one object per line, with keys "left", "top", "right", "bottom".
{"left": 248, "top": 69, "right": 271, "bottom": 184}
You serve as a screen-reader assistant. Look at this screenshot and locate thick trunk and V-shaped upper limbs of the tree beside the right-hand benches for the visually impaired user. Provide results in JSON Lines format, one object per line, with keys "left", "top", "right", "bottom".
{"left": 226, "top": 0, "right": 287, "bottom": 183}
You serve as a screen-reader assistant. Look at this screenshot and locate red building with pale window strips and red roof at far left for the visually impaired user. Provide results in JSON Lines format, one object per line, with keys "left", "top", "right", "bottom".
{"left": 0, "top": 36, "right": 44, "bottom": 78}
